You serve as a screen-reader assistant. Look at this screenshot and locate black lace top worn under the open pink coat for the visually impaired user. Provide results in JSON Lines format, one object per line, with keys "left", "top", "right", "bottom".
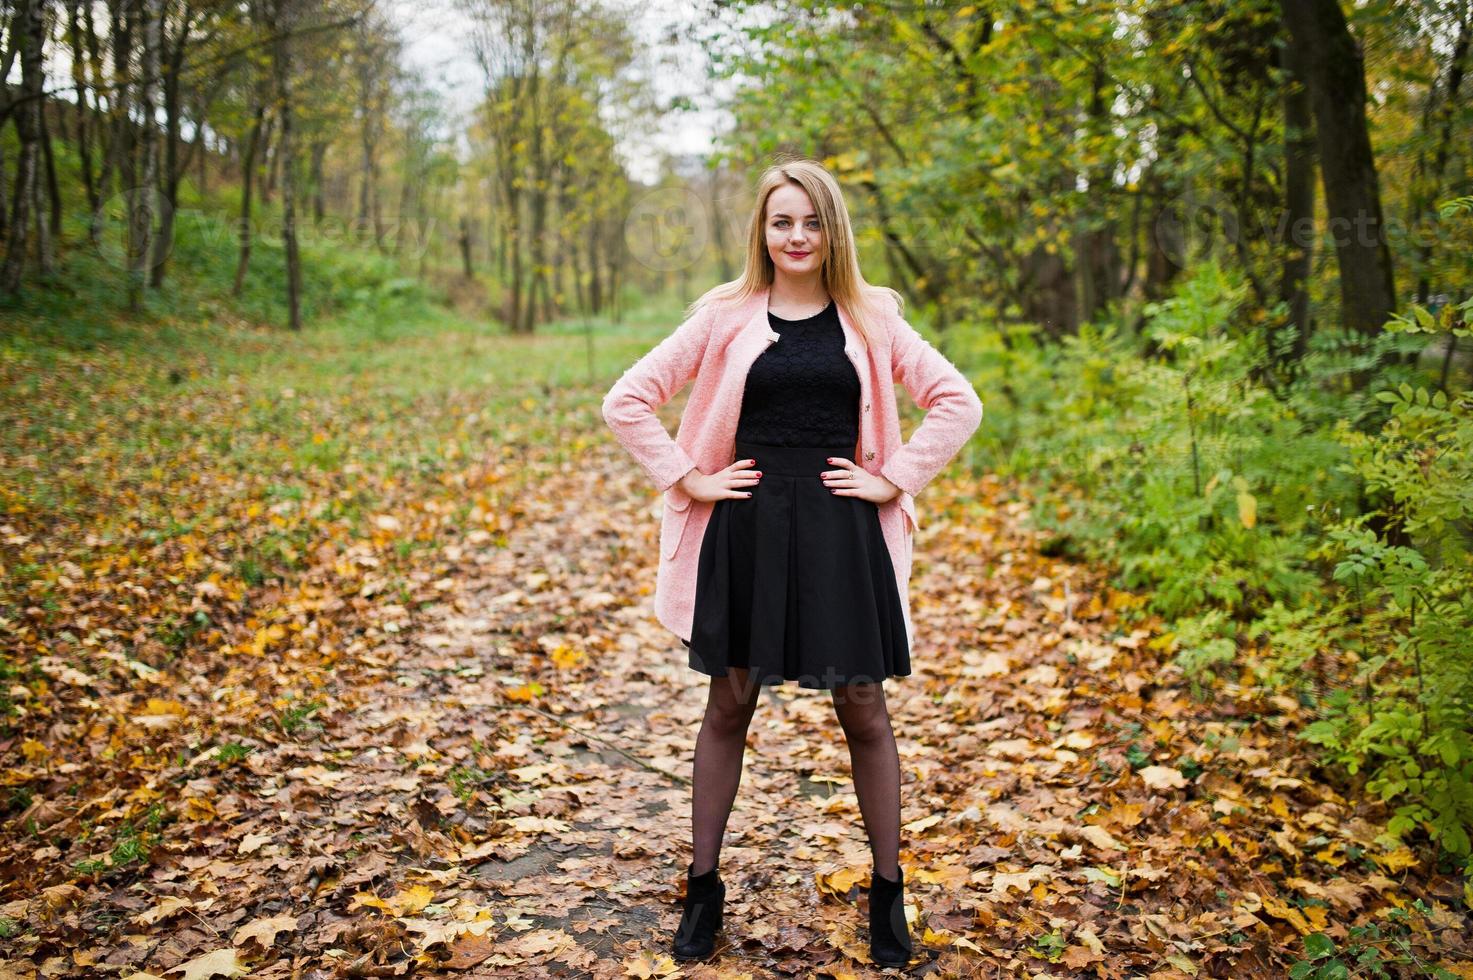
{"left": 737, "top": 299, "right": 860, "bottom": 447}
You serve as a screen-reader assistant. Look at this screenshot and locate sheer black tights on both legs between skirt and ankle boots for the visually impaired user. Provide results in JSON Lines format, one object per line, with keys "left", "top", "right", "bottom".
{"left": 691, "top": 668, "right": 900, "bottom": 878}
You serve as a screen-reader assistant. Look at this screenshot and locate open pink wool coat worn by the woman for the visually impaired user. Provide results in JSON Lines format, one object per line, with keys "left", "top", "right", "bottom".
{"left": 602, "top": 289, "right": 982, "bottom": 648}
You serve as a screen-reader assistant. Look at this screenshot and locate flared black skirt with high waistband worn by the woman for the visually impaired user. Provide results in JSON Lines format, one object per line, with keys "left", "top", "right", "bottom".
{"left": 682, "top": 441, "right": 910, "bottom": 690}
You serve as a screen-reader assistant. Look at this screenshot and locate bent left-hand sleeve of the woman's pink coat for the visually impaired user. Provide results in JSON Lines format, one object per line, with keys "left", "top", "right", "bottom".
{"left": 602, "top": 304, "right": 713, "bottom": 492}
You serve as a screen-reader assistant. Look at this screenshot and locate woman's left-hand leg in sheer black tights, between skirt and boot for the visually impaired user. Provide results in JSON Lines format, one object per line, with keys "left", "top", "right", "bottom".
{"left": 691, "top": 668, "right": 757, "bottom": 875}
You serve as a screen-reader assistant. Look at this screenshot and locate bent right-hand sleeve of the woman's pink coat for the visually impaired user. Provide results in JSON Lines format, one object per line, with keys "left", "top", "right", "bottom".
{"left": 879, "top": 314, "right": 982, "bottom": 497}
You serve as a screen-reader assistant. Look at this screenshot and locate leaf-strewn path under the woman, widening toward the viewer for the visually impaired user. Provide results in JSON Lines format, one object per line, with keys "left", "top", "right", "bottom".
{"left": 0, "top": 441, "right": 1469, "bottom": 979}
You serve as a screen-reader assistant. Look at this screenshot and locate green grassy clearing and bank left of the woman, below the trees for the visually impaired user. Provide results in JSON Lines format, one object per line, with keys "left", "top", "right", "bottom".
{"left": 0, "top": 180, "right": 679, "bottom": 538}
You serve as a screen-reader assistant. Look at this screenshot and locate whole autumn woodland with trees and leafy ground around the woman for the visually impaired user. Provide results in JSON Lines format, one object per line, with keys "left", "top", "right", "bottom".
{"left": 0, "top": 0, "right": 1473, "bottom": 977}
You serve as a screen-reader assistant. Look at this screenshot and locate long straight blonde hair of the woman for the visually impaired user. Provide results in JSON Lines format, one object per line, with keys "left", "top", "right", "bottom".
{"left": 685, "top": 159, "right": 904, "bottom": 345}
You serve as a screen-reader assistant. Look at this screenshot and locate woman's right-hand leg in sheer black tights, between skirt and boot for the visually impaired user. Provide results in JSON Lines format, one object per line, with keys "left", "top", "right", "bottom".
{"left": 834, "top": 682, "right": 900, "bottom": 878}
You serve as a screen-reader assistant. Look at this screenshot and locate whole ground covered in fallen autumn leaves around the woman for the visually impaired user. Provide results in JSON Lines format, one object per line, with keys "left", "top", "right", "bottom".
{"left": 0, "top": 309, "right": 1473, "bottom": 979}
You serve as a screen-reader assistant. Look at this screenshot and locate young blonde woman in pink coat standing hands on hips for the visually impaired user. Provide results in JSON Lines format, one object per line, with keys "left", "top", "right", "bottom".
{"left": 602, "top": 161, "right": 982, "bottom": 965}
